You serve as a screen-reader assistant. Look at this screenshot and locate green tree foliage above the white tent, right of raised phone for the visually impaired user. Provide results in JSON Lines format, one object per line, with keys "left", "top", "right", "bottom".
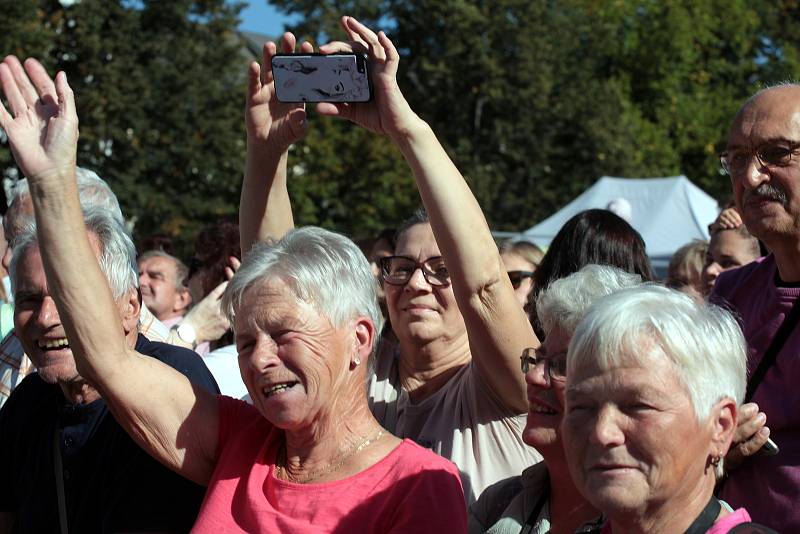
{"left": 273, "top": 0, "right": 800, "bottom": 230}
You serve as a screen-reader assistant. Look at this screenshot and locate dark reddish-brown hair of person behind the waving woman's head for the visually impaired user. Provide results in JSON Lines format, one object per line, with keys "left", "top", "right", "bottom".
{"left": 189, "top": 221, "right": 242, "bottom": 296}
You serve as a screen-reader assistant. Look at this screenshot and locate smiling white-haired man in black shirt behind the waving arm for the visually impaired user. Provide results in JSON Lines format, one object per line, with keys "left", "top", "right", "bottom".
{"left": 0, "top": 209, "right": 218, "bottom": 532}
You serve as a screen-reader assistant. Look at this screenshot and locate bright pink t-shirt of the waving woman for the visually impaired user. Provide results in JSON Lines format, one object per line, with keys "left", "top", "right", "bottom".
{"left": 192, "top": 396, "right": 467, "bottom": 534}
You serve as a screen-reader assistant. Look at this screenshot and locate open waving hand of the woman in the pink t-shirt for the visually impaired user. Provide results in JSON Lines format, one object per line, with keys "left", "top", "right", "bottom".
{"left": 0, "top": 56, "right": 78, "bottom": 183}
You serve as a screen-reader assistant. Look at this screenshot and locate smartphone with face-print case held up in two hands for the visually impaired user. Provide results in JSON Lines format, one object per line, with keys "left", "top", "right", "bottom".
{"left": 272, "top": 54, "right": 372, "bottom": 103}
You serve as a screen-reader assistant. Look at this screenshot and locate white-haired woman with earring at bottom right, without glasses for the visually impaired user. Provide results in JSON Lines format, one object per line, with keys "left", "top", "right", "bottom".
{"left": 562, "top": 286, "right": 770, "bottom": 534}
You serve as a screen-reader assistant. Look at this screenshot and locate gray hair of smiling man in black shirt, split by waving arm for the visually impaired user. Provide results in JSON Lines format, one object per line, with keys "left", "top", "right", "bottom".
{"left": 9, "top": 206, "right": 139, "bottom": 300}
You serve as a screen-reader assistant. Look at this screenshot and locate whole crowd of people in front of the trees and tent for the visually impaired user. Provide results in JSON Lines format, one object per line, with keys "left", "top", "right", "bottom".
{"left": 0, "top": 17, "right": 800, "bottom": 534}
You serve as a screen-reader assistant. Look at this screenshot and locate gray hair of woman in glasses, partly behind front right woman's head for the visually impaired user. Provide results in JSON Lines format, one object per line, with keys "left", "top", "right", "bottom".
{"left": 536, "top": 264, "right": 642, "bottom": 337}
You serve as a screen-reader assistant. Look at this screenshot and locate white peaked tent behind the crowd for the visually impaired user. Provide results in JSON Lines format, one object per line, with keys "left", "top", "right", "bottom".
{"left": 520, "top": 176, "right": 719, "bottom": 274}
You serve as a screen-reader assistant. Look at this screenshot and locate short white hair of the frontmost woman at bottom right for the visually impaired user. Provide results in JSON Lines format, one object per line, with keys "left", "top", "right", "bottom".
{"left": 567, "top": 284, "right": 747, "bottom": 423}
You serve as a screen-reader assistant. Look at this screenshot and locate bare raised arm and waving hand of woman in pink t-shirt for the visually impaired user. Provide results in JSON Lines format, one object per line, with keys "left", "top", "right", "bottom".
{"left": 0, "top": 57, "right": 218, "bottom": 484}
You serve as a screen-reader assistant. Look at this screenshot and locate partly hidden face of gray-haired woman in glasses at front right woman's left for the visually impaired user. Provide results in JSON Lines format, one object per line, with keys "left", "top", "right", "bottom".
{"left": 522, "top": 328, "right": 570, "bottom": 459}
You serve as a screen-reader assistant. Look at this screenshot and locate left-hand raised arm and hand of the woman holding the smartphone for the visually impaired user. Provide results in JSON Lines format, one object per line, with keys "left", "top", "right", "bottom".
{"left": 239, "top": 33, "right": 312, "bottom": 255}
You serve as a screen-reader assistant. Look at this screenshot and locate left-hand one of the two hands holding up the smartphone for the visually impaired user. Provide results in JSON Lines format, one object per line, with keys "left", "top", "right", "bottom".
{"left": 245, "top": 33, "right": 313, "bottom": 151}
